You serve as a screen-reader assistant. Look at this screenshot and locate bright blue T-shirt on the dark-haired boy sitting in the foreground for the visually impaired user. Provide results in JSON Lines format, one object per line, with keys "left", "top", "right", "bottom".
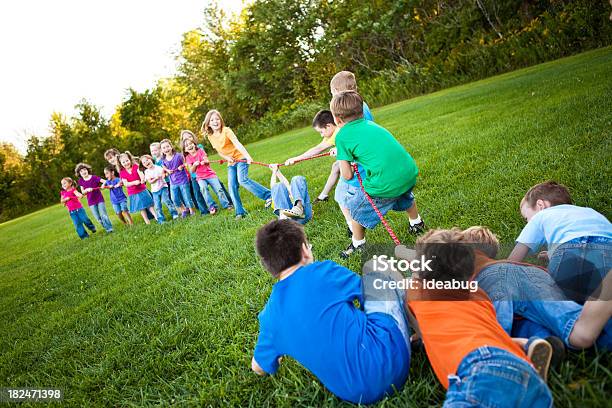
{"left": 255, "top": 261, "right": 410, "bottom": 403}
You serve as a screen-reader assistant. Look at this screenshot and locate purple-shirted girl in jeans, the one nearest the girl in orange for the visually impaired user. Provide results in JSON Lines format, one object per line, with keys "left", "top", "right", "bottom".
{"left": 160, "top": 139, "right": 195, "bottom": 218}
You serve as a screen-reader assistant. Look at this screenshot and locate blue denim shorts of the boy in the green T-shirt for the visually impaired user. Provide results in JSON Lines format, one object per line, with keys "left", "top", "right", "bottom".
{"left": 346, "top": 187, "right": 414, "bottom": 229}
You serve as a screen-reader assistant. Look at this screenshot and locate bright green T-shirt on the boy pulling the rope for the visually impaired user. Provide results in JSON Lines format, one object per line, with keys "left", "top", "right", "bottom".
{"left": 336, "top": 119, "right": 419, "bottom": 198}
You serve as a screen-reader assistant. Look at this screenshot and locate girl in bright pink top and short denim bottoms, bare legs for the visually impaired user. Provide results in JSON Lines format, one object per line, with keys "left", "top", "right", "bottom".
{"left": 119, "top": 152, "right": 159, "bottom": 224}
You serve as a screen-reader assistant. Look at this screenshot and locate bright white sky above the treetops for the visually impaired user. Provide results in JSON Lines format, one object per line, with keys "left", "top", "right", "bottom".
{"left": 0, "top": 0, "right": 242, "bottom": 152}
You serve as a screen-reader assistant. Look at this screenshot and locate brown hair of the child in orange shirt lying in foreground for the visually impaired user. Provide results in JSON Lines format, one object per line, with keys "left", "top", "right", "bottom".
{"left": 416, "top": 228, "right": 474, "bottom": 281}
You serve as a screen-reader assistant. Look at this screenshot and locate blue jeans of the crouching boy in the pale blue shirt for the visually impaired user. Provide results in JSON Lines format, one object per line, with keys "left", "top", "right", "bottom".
{"left": 548, "top": 237, "right": 612, "bottom": 303}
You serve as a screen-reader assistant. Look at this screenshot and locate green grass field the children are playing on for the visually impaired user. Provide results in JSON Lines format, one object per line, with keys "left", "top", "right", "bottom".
{"left": 0, "top": 48, "right": 612, "bottom": 407}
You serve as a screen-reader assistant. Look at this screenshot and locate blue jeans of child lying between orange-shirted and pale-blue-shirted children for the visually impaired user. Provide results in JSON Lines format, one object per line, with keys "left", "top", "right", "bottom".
{"left": 476, "top": 262, "right": 609, "bottom": 346}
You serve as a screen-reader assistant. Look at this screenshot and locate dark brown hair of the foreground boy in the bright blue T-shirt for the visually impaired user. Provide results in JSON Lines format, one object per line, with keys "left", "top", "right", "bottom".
{"left": 255, "top": 220, "right": 307, "bottom": 278}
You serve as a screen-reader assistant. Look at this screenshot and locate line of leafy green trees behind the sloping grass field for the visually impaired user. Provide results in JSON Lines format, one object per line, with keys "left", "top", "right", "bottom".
{"left": 0, "top": 0, "right": 612, "bottom": 221}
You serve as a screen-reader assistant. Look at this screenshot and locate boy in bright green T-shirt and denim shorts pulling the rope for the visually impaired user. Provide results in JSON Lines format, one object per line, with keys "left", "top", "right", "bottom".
{"left": 330, "top": 91, "right": 425, "bottom": 258}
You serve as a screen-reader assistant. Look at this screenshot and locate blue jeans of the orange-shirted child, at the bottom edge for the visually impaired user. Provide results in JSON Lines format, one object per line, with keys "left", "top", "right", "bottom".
{"left": 444, "top": 346, "right": 553, "bottom": 408}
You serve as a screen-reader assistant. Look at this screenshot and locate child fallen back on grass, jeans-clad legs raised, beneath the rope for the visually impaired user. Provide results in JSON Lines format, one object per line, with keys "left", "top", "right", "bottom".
{"left": 270, "top": 164, "right": 312, "bottom": 224}
